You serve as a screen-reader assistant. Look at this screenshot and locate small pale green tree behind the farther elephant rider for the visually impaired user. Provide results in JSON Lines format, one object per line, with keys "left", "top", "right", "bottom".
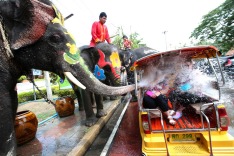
{"left": 112, "top": 27, "right": 146, "bottom": 49}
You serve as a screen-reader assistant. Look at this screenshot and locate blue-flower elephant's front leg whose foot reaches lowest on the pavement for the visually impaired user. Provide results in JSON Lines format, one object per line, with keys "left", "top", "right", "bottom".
{"left": 81, "top": 90, "right": 98, "bottom": 127}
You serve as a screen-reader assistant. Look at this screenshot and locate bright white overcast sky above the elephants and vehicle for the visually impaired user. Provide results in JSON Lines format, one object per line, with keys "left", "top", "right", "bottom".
{"left": 52, "top": 0, "right": 225, "bottom": 51}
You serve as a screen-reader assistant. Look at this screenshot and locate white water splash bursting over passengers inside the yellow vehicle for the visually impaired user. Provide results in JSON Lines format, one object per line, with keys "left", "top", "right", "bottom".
{"left": 139, "top": 56, "right": 219, "bottom": 100}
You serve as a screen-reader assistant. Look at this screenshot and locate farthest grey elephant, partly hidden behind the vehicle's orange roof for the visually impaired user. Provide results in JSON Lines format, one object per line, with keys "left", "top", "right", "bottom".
{"left": 119, "top": 46, "right": 159, "bottom": 84}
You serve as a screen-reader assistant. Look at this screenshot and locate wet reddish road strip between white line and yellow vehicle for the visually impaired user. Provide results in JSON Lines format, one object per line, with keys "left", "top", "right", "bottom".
{"left": 107, "top": 102, "right": 142, "bottom": 156}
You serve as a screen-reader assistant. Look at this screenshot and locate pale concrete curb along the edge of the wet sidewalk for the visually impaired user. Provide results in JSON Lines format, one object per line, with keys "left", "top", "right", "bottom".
{"left": 68, "top": 99, "right": 121, "bottom": 156}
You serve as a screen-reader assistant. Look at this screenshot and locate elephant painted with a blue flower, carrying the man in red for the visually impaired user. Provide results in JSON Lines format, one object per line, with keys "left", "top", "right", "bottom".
{"left": 71, "top": 43, "right": 121, "bottom": 126}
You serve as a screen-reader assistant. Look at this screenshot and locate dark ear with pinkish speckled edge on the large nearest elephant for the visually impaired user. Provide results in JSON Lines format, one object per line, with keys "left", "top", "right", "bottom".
{"left": 11, "top": 0, "right": 55, "bottom": 50}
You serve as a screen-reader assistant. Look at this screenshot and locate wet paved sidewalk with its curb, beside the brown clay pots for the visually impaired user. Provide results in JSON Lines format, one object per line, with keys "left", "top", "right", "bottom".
{"left": 17, "top": 97, "right": 121, "bottom": 156}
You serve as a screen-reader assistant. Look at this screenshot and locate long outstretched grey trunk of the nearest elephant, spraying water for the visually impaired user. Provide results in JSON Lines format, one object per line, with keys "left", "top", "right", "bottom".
{"left": 72, "top": 65, "right": 135, "bottom": 95}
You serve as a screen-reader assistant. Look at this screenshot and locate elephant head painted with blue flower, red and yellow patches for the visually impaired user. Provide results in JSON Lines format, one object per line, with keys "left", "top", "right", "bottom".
{"left": 80, "top": 43, "right": 121, "bottom": 86}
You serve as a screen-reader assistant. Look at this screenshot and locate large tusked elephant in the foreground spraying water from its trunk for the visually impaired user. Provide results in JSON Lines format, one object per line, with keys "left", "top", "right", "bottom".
{"left": 0, "top": 0, "right": 135, "bottom": 155}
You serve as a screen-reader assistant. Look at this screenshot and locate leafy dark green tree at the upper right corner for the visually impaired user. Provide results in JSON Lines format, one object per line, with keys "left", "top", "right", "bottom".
{"left": 190, "top": 0, "right": 234, "bottom": 53}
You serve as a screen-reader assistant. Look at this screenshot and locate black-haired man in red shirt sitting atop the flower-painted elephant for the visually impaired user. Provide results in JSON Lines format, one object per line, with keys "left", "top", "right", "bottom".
{"left": 90, "top": 12, "right": 111, "bottom": 47}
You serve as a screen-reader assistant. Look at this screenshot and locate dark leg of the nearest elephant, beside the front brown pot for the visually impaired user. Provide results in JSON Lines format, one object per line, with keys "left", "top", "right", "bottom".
{"left": 0, "top": 93, "right": 17, "bottom": 155}
